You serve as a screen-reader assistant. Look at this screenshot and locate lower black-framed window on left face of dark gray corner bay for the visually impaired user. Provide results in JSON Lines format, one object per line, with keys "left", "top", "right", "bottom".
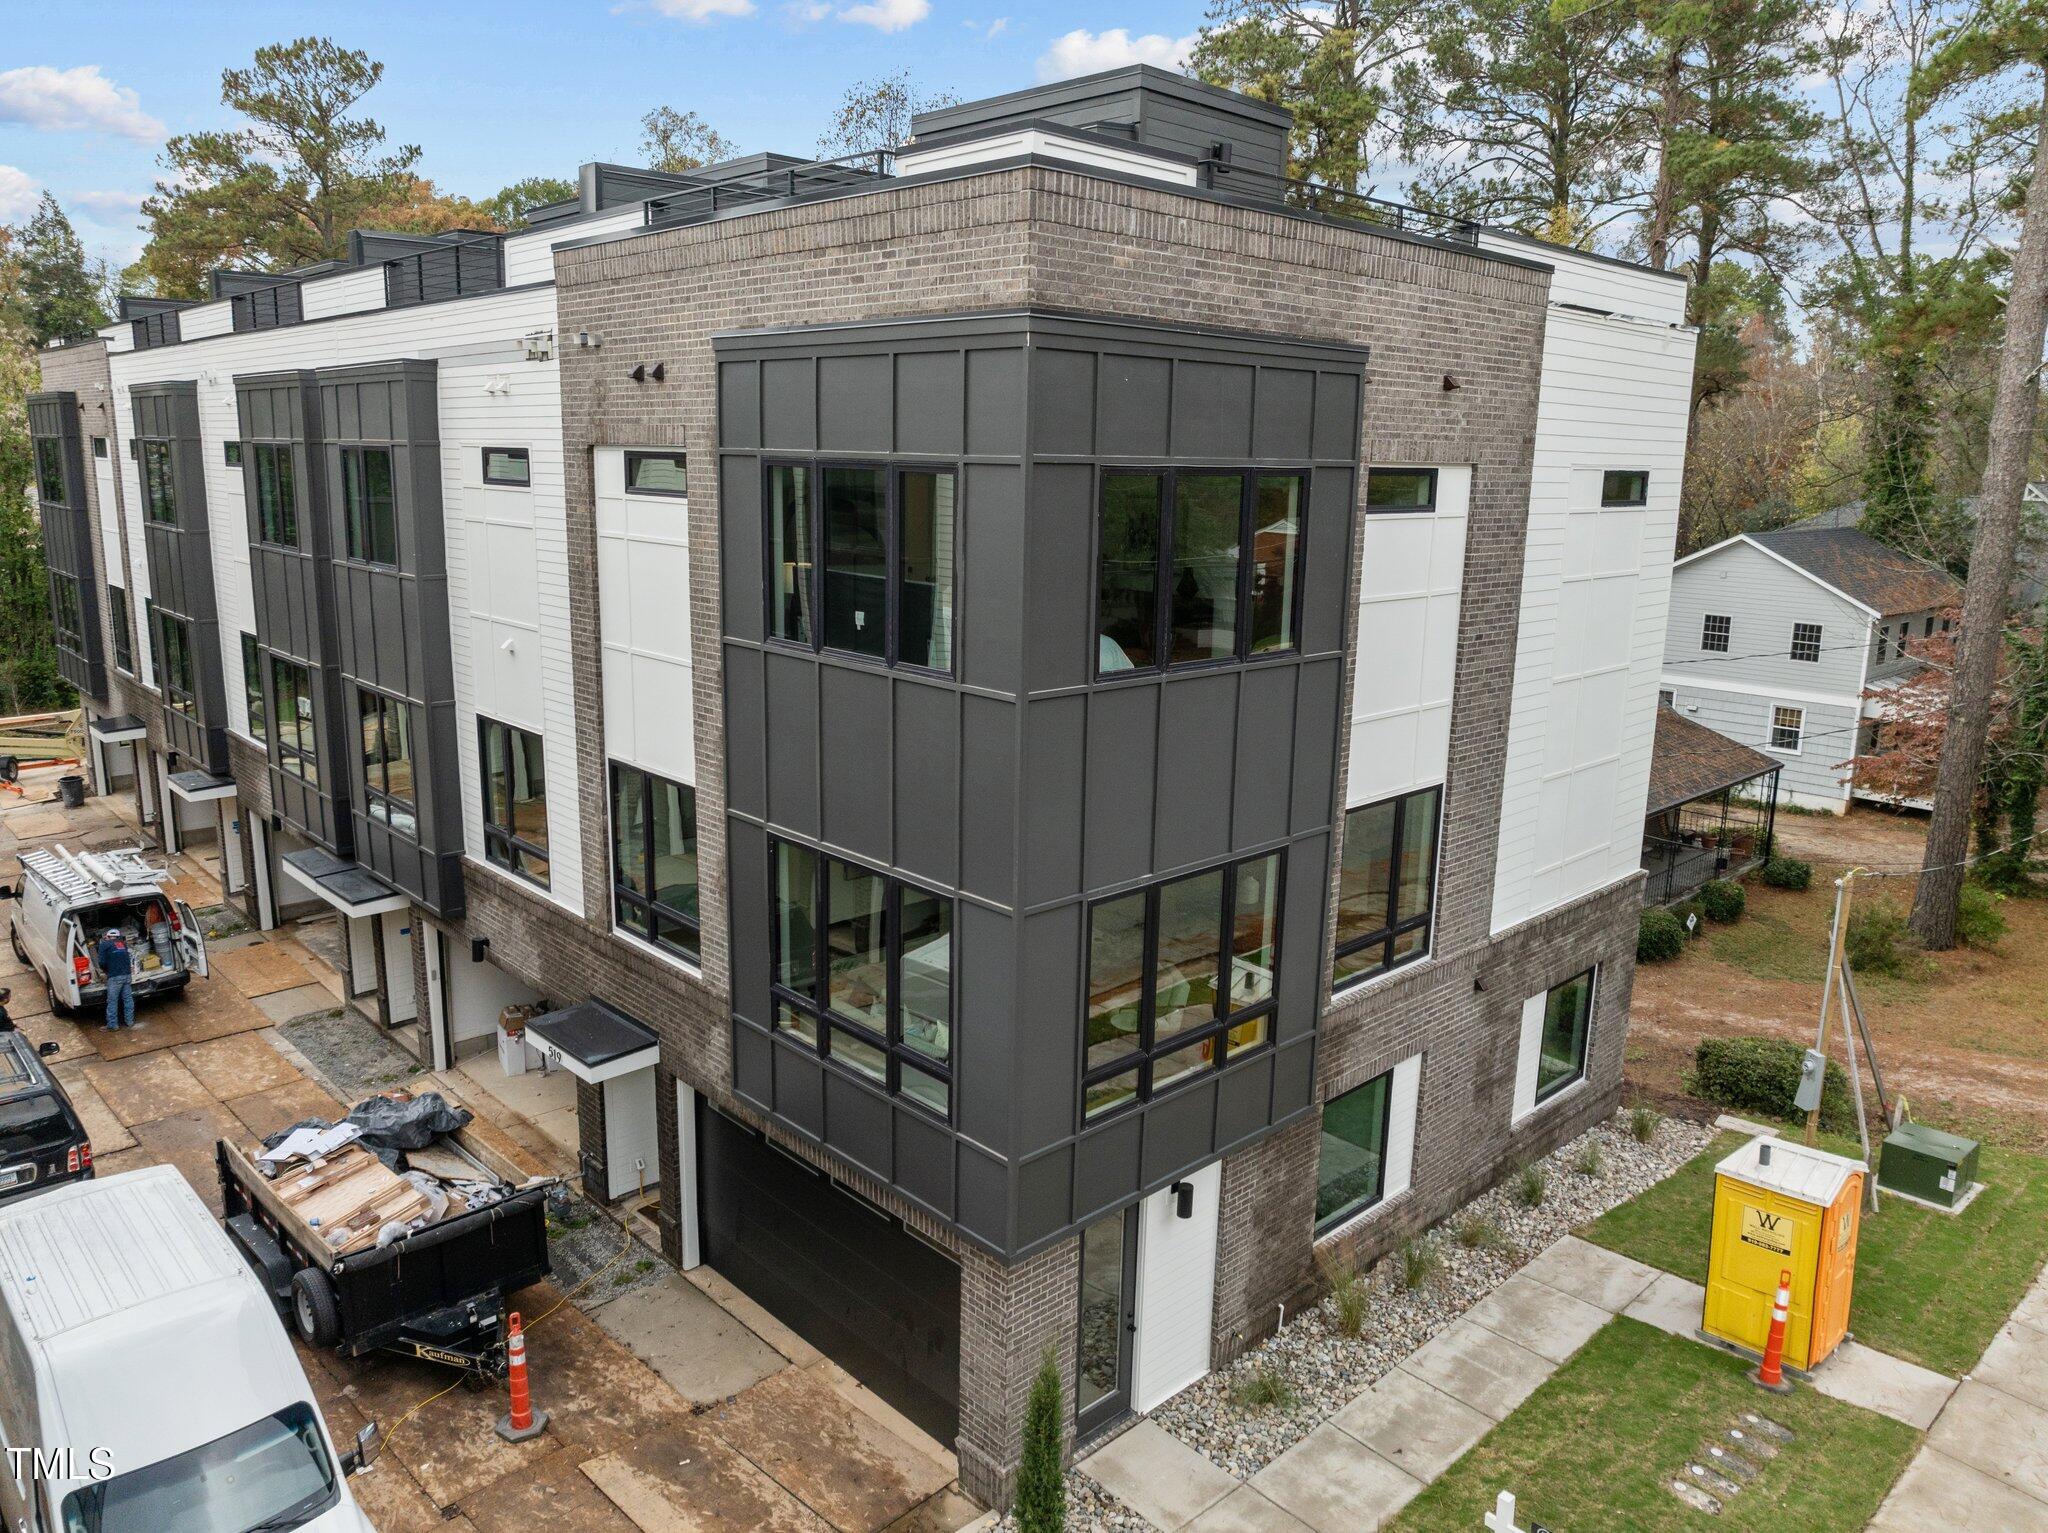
{"left": 768, "top": 839, "right": 952, "bottom": 1118}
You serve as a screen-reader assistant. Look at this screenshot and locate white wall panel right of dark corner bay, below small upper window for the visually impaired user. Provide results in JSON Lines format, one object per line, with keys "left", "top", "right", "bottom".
{"left": 1343, "top": 467, "right": 1473, "bottom": 808}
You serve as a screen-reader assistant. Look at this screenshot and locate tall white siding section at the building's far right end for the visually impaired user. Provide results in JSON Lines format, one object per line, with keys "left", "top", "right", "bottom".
{"left": 1493, "top": 303, "right": 1694, "bottom": 931}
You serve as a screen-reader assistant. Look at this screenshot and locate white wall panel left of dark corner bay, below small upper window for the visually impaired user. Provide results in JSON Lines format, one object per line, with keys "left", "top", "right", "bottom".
{"left": 592, "top": 442, "right": 696, "bottom": 786}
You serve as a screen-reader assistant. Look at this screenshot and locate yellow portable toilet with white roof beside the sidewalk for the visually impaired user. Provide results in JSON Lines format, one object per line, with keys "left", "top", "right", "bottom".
{"left": 1700, "top": 1138, "right": 1868, "bottom": 1369}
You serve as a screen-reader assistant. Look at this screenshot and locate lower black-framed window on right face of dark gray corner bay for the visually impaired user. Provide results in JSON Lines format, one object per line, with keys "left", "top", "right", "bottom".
{"left": 1081, "top": 851, "right": 1286, "bottom": 1120}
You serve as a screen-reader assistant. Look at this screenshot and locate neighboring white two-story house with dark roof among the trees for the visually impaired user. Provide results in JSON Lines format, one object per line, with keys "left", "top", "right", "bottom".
{"left": 1663, "top": 528, "right": 1962, "bottom": 815}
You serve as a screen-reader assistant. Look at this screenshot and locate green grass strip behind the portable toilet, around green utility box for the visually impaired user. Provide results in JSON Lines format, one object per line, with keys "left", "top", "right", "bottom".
{"left": 1579, "top": 1134, "right": 2048, "bottom": 1377}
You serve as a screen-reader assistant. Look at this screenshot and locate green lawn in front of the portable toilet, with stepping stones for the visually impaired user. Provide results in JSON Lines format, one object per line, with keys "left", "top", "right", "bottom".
{"left": 1384, "top": 1320, "right": 1921, "bottom": 1533}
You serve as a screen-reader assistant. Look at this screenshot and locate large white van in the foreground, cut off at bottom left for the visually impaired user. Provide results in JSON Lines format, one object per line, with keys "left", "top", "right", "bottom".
{"left": 0, "top": 1167, "right": 377, "bottom": 1533}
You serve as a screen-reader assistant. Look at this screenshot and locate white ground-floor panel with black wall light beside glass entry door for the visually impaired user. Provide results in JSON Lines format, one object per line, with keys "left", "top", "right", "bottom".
{"left": 1130, "top": 1160, "right": 1223, "bottom": 1410}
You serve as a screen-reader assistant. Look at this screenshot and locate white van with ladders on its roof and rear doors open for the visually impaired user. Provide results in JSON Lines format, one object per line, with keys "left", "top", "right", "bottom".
{"left": 8, "top": 847, "right": 207, "bottom": 1017}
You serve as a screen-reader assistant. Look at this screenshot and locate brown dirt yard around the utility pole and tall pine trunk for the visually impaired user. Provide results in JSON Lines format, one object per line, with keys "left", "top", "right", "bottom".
{"left": 1626, "top": 808, "right": 2048, "bottom": 1150}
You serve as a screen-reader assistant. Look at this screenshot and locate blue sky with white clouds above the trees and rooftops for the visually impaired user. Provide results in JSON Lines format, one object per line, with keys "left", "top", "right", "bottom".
{"left": 0, "top": 0, "right": 1204, "bottom": 262}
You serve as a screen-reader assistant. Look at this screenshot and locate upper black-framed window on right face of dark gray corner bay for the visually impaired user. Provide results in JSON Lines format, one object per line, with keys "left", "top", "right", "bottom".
{"left": 1096, "top": 469, "right": 1309, "bottom": 677}
